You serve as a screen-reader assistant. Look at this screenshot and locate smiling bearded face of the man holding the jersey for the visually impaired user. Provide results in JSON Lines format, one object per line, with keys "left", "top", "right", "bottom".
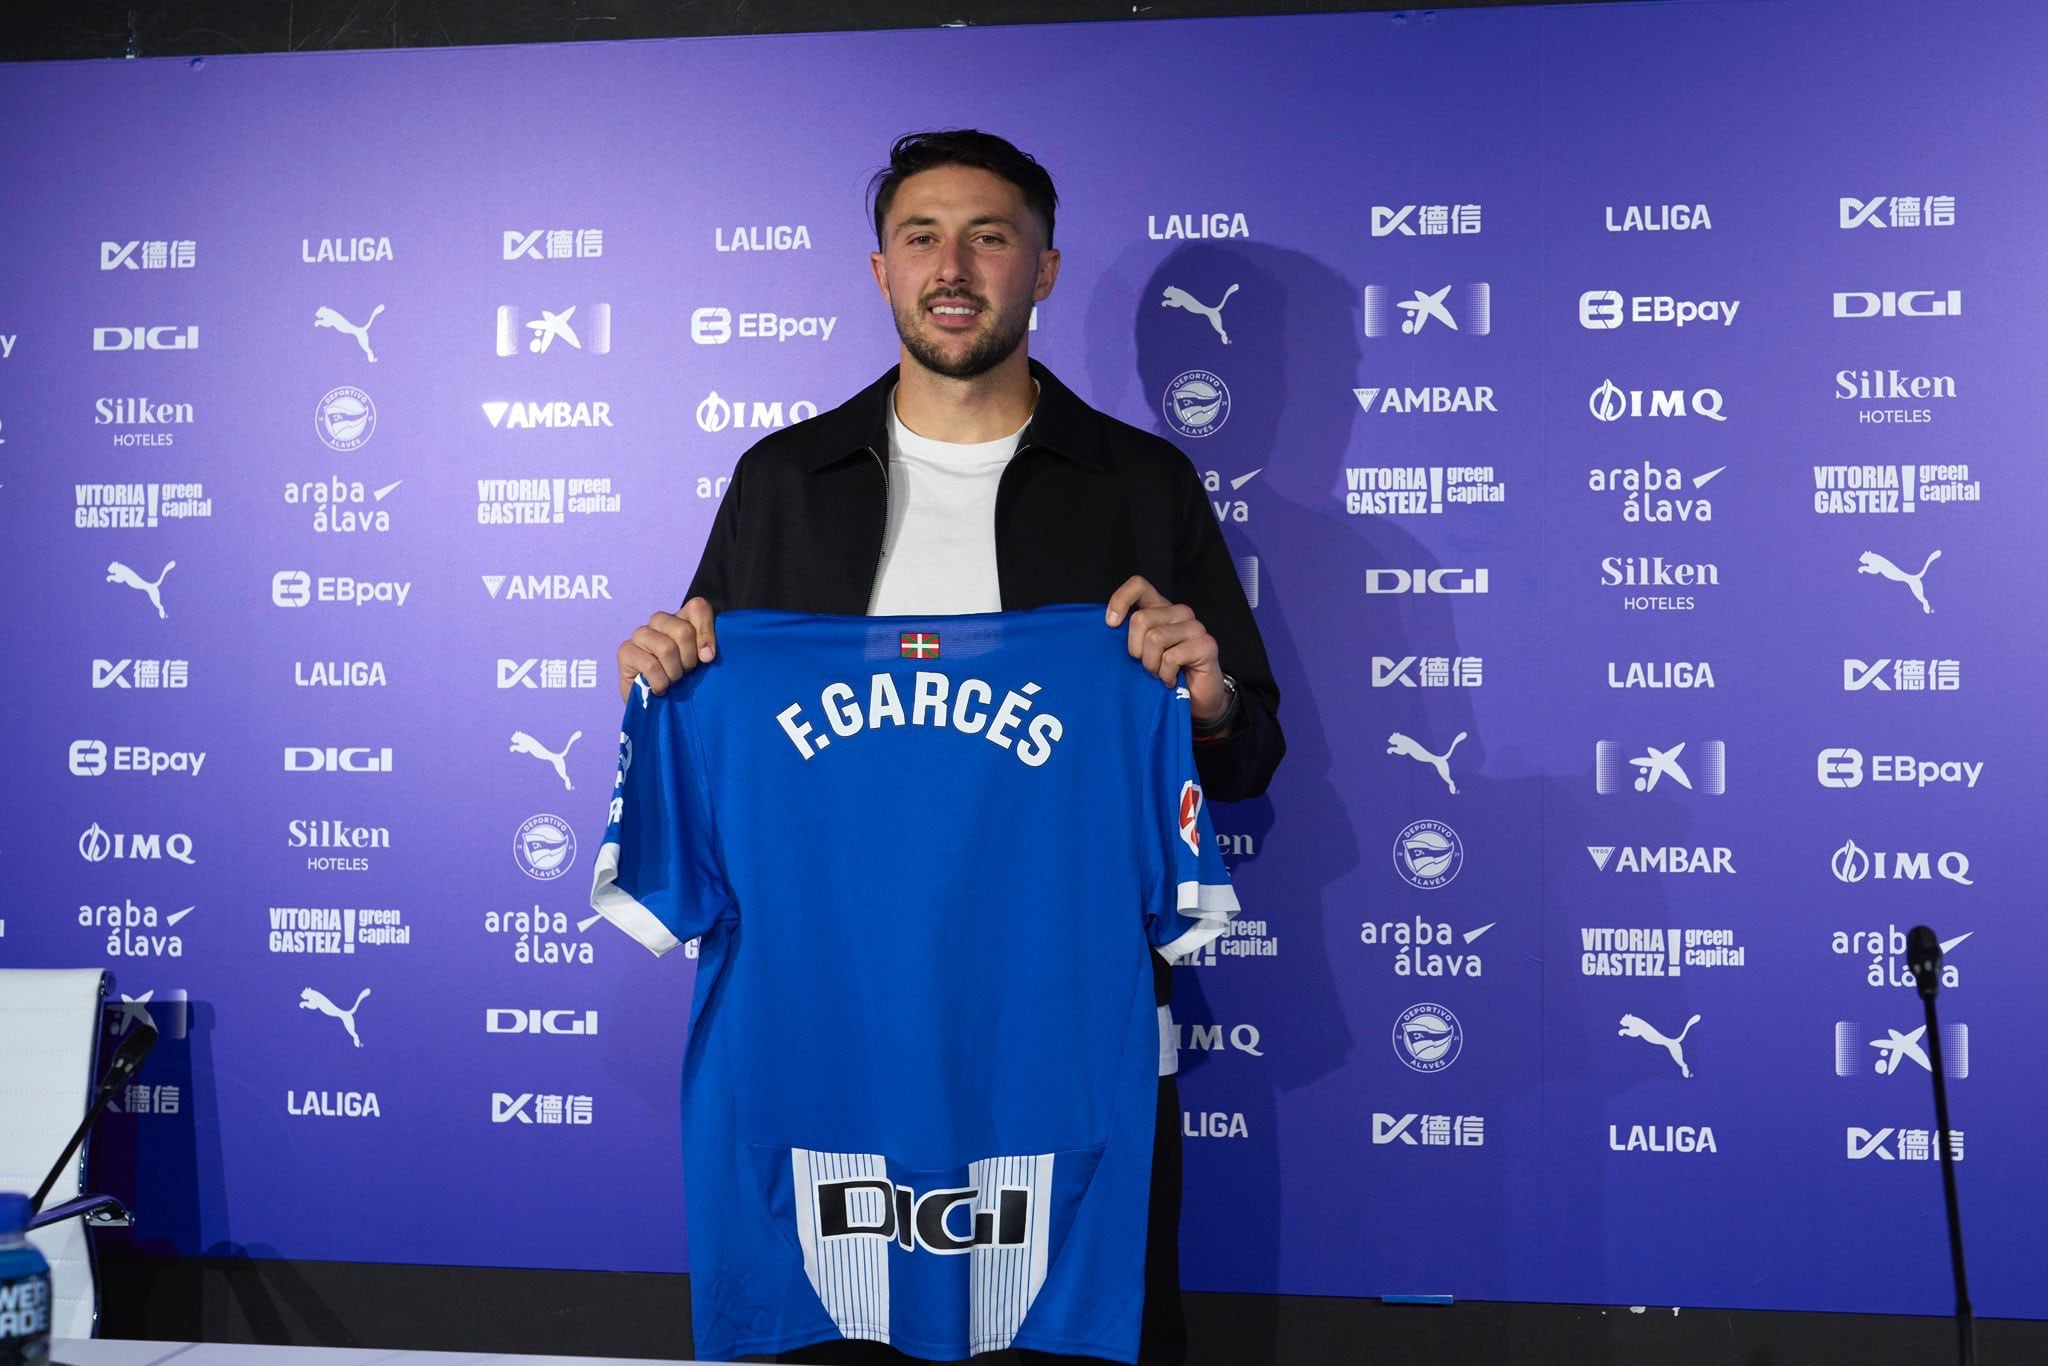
{"left": 872, "top": 166, "right": 1059, "bottom": 379}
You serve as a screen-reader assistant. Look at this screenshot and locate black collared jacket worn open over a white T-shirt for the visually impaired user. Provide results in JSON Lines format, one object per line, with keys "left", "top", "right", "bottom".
{"left": 690, "top": 360, "right": 1286, "bottom": 801}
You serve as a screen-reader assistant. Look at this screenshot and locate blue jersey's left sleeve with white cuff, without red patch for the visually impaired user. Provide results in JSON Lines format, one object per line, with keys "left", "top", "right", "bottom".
{"left": 590, "top": 688, "right": 737, "bottom": 954}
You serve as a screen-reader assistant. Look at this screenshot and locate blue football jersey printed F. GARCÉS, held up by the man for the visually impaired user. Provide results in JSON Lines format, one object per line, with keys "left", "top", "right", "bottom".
{"left": 592, "top": 606, "right": 1237, "bottom": 1362}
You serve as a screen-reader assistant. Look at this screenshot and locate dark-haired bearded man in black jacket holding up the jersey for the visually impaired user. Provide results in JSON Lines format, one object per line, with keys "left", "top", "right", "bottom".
{"left": 618, "top": 131, "right": 1284, "bottom": 1364}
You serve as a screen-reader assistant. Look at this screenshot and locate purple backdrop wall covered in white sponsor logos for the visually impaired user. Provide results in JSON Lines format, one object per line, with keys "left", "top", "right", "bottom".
{"left": 0, "top": 2, "right": 2048, "bottom": 1317}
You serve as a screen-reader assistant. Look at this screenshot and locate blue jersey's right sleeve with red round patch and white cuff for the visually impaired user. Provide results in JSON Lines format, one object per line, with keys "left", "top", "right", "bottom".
{"left": 1145, "top": 688, "right": 1237, "bottom": 963}
